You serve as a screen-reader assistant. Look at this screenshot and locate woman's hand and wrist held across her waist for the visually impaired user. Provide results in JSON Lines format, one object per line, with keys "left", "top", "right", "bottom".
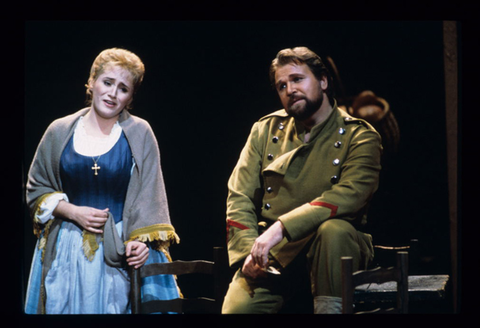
{"left": 53, "top": 200, "right": 108, "bottom": 233}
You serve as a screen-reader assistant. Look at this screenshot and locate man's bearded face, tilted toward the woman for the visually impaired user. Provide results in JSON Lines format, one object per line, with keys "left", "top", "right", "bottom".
{"left": 275, "top": 63, "right": 328, "bottom": 121}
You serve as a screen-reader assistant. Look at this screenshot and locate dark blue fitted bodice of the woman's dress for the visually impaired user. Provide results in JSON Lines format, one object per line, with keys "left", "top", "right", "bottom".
{"left": 60, "top": 132, "right": 133, "bottom": 223}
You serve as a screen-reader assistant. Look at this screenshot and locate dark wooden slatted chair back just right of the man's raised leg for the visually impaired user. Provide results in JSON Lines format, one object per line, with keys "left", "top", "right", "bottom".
{"left": 342, "top": 252, "right": 408, "bottom": 314}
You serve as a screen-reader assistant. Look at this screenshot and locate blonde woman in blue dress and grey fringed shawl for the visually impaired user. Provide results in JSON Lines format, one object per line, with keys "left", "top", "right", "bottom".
{"left": 25, "top": 48, "right": 179, "bottom": 314}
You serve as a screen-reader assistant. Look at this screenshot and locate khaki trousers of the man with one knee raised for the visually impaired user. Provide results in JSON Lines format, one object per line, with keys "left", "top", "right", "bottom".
{"left": 222, "top": 219, "right": 373, "bottom": 314}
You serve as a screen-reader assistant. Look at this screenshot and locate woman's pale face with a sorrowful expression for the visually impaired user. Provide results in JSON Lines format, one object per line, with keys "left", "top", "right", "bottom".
{"left": 92, "top": 66, "right": 133, "bottom": 119}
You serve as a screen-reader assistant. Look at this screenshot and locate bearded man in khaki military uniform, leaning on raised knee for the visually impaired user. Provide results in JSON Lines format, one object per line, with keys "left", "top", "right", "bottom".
{"left": 223, "top": 47, "right": 381, "bottom": 313}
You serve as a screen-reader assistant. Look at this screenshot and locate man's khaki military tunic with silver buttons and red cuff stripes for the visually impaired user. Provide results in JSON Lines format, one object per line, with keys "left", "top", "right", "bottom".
{"left": 227, "top": 104, "right": 382, "bottom": 267}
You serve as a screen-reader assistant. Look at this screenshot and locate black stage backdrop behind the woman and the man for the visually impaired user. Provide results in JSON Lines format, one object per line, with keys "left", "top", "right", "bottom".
{"left": 23, "top": 21, "right": 450, "bottom": 304}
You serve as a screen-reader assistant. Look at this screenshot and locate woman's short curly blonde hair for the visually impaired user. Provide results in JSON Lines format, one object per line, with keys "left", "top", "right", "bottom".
{"left": 85, "top": 48, "right": 145, "bottom": 109}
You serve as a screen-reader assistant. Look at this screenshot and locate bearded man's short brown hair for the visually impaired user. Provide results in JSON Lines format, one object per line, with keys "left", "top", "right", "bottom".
{"left": 269, "top": 47, "right": 333, "bottom": 102}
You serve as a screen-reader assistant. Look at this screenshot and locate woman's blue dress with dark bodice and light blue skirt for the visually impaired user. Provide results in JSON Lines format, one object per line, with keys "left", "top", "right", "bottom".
{"left": 25, "top": 132, "right": 179, "bottom": 314}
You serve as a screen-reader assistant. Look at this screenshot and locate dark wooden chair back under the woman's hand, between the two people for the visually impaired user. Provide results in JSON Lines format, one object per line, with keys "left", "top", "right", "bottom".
{"left": 130, "top": 247, "right": 224, "bottom": 314}
